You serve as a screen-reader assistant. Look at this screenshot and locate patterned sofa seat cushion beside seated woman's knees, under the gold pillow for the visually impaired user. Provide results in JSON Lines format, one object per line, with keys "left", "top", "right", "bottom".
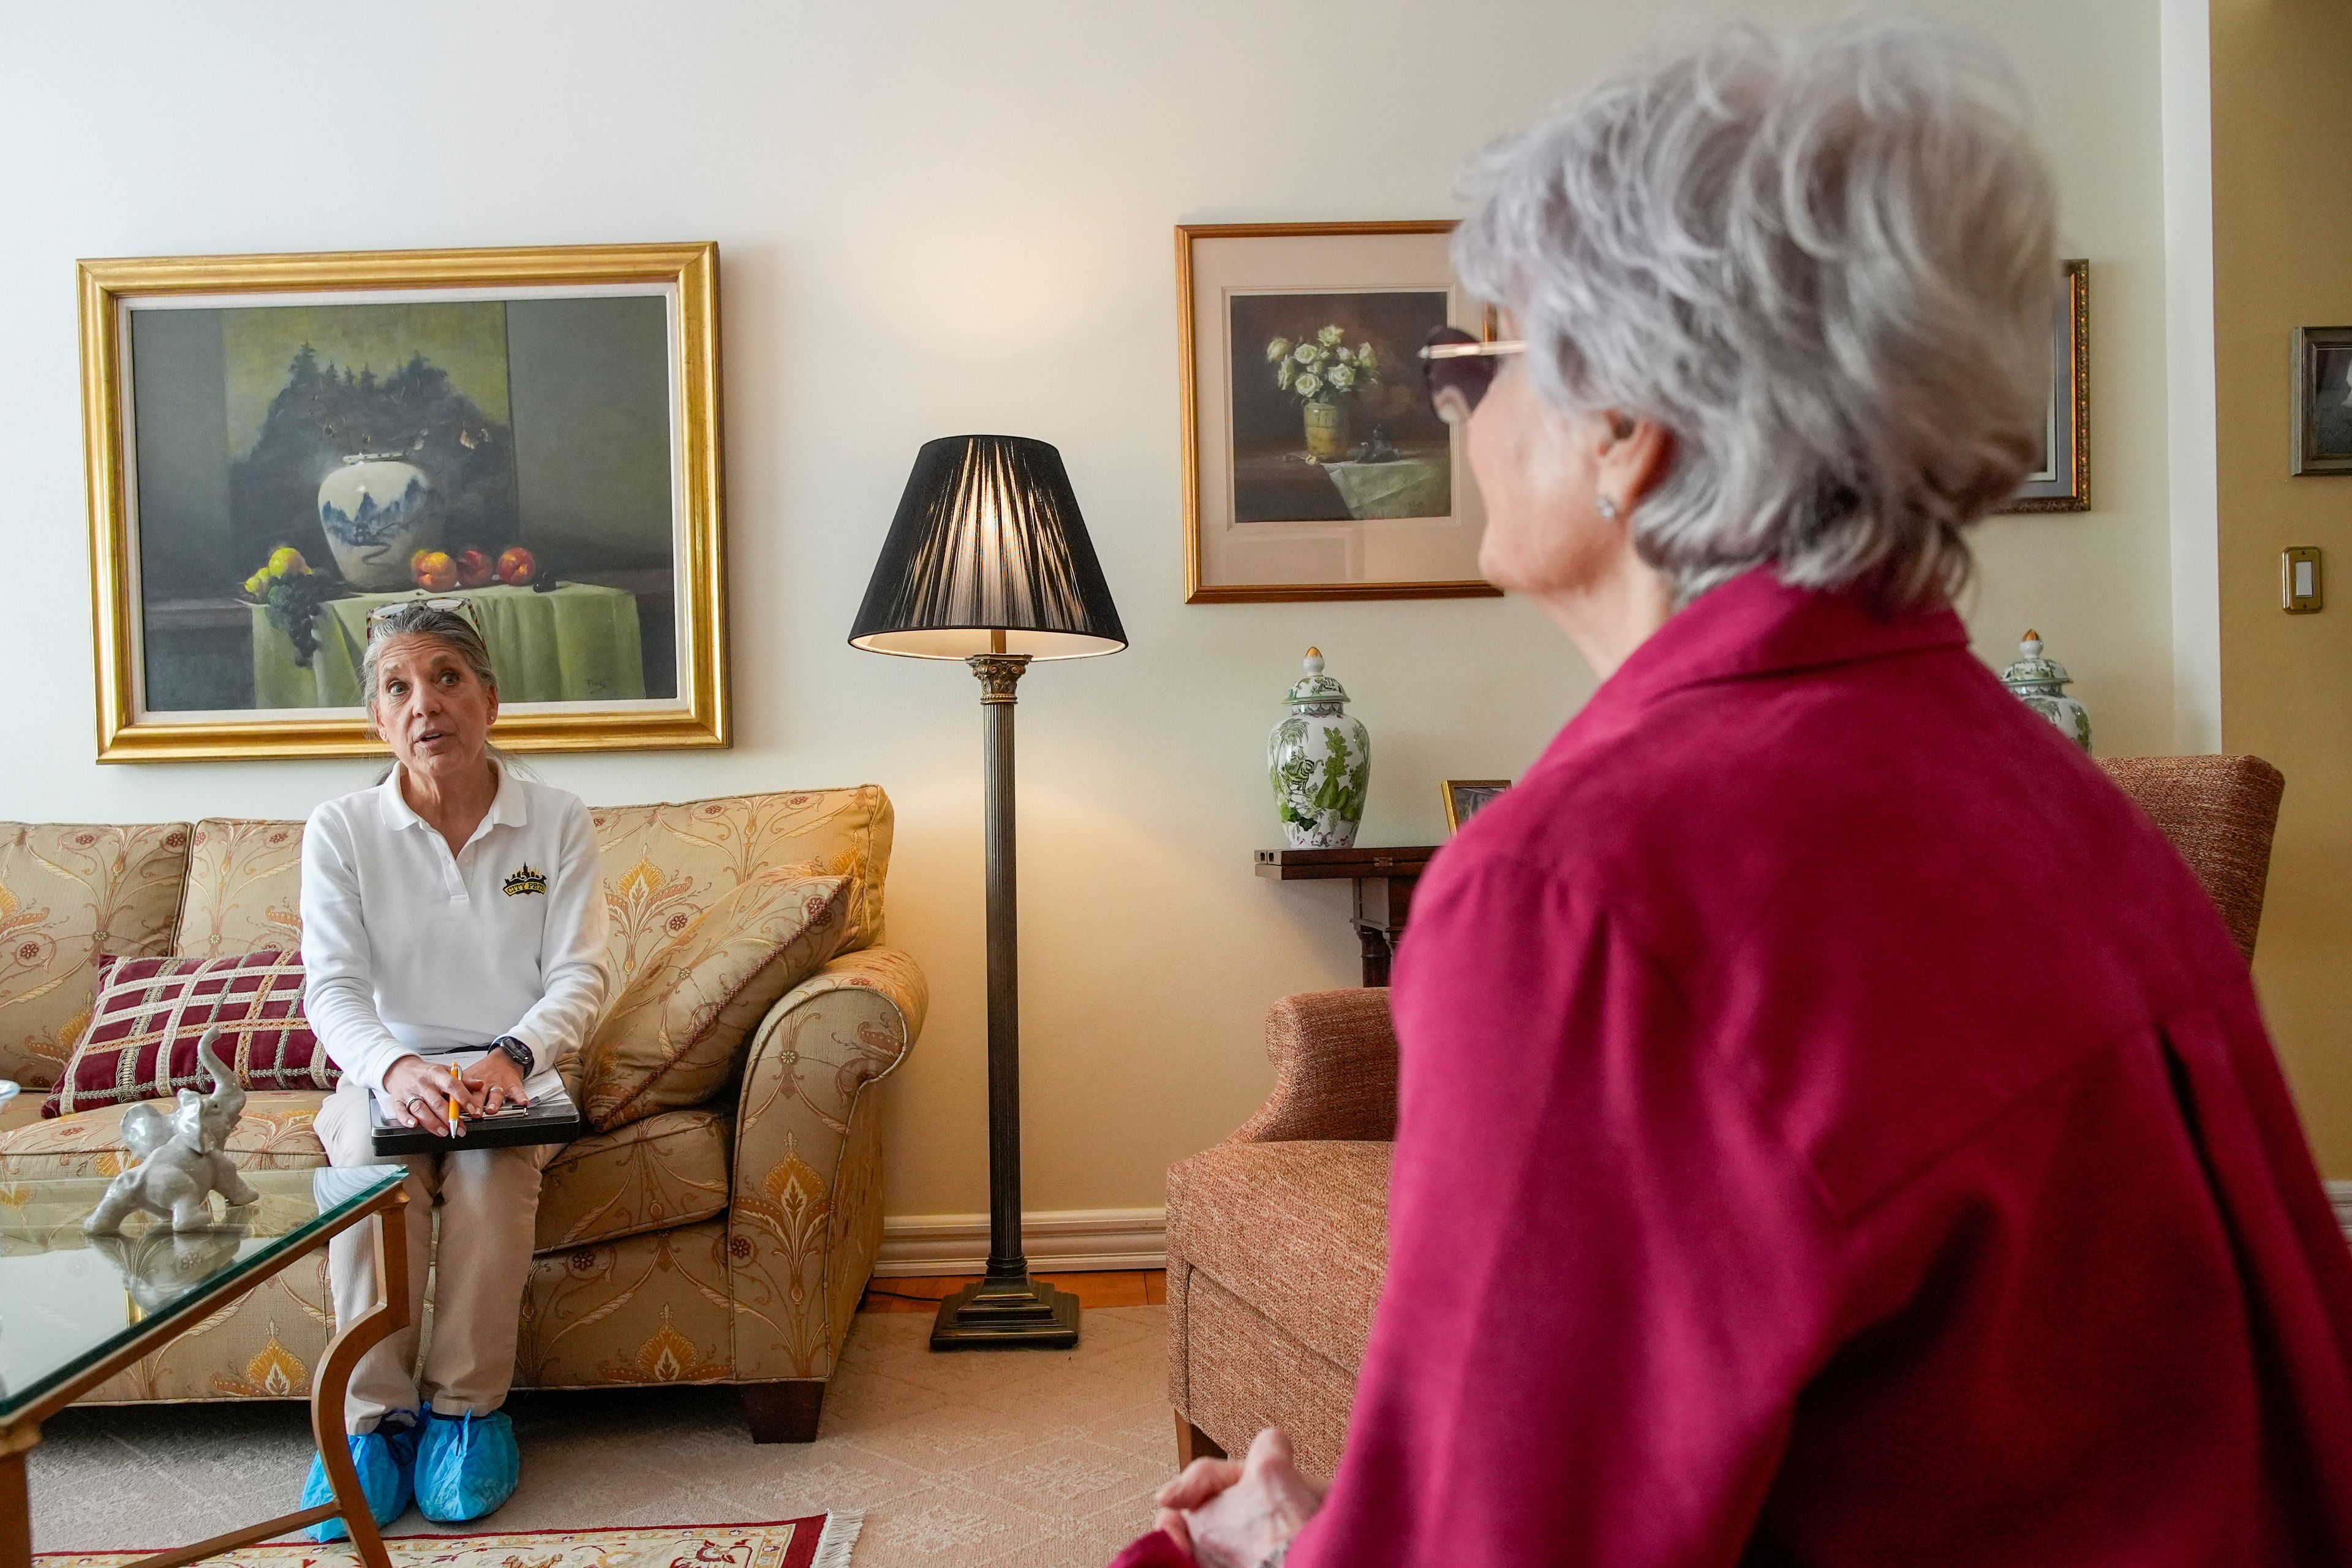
{"left": 534, "top": 1110, "right": 734, "bottom": 1253}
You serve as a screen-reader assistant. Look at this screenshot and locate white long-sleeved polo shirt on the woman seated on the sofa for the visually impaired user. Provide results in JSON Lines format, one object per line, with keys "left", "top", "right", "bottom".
{"left": 301, "top": 766, "right": 607, "bottom": 1088}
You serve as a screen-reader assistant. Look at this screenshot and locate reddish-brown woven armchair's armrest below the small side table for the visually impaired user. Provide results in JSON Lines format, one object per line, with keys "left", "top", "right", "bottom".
{"left": 1230, "top": 987, "right": 1397, "bottom": 1142}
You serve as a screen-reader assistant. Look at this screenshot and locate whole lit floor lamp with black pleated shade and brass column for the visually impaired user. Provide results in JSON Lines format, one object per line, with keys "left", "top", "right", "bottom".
{"left": 849, "top": 435, "right": 1126, "bottom": 1349}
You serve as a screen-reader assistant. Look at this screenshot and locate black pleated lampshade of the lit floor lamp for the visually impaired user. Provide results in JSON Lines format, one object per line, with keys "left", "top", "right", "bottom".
{"left": 849, "top": 435, "right": 1126, "bottom": 658}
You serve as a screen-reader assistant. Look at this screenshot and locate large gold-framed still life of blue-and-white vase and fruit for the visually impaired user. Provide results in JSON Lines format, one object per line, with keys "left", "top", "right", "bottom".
{"left": 80, "top": 242, "right": 727, "bottom": 762}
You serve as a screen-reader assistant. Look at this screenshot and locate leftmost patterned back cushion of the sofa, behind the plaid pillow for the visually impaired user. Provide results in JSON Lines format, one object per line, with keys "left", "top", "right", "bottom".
{"left": 0, "top": 823, "right": 188, "bottom": 1088}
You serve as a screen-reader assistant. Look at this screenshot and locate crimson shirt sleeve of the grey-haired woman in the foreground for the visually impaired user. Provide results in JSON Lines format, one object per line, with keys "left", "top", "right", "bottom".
{"left": 1291, "top": 856, "right": 1839, "bottom": 1568}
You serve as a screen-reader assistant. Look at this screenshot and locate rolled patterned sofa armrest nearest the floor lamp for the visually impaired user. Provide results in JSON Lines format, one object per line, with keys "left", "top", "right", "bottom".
{"left": 727, "top": 948, "right": 929, "bottom": 1382}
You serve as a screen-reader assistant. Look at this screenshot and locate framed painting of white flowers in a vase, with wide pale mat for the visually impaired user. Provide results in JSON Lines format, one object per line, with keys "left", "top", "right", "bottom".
{"left": 1176, "top": 221, "right": 1501, "bottom": 604}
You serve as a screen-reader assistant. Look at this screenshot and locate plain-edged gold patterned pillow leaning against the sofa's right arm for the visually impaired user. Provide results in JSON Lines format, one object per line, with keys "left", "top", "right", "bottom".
{"left": 583, "top": 867, "right": 854, "bottom": 1133}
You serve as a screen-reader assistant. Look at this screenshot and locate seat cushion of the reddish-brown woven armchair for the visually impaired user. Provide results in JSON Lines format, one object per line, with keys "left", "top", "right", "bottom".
{"left": 1169, "top": 1140, "right": 1392, "bottom": 1368}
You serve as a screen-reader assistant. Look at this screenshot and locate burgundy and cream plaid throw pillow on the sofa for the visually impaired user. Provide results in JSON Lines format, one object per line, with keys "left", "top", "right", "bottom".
{"left": 40, "top": 952, "right": 341, "bottom": 1117}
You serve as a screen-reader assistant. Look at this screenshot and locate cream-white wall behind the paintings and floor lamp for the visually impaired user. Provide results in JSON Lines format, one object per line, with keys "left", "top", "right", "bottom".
{"left": 0, "top": 0, "right": 2173, "bottom": 1213}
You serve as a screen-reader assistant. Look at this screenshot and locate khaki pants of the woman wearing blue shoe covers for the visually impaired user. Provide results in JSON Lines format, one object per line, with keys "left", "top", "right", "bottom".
{"left": 315, "top": 1077, "right": 560, "bottom": 1431}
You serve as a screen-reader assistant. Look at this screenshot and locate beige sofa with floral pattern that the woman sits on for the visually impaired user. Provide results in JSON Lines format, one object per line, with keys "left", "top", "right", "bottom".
{"left": 0, "top": 785, "right": 927, "bottom": 1441}
